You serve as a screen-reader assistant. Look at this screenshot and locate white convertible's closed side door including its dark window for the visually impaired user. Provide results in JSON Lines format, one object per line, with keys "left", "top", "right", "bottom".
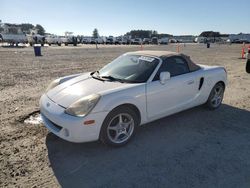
{"left": 146, "top": 56, "right": 199, "bottom": 119}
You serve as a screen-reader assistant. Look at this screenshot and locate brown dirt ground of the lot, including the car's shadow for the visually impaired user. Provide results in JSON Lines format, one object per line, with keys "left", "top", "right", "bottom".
{"left": 0, "top": 44, "right": 250, "bottom": 188}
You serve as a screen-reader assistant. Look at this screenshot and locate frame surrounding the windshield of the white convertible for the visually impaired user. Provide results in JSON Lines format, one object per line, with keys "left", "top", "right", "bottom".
{"left": 94, "top": 52, "right": 162, "bottom": 84}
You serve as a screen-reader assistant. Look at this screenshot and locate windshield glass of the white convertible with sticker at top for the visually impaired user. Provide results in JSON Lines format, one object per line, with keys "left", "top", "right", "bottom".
{"left": 92, "top": 55, "right": 159, "bottom": 83}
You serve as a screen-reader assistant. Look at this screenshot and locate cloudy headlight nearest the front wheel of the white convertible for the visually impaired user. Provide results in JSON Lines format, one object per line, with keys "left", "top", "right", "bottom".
{"left": 65, "top": 94, "right": 101, "bottom": 117}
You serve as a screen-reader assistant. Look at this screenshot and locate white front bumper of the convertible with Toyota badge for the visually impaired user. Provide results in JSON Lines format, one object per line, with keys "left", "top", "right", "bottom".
{"left": 40, "top": 94, "right": 108, "bottom": 143}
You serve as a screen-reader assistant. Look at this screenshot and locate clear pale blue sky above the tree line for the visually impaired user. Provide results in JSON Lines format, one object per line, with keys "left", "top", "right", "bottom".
{"left": 0, "top": 0, "right": 250, "bottom": 36}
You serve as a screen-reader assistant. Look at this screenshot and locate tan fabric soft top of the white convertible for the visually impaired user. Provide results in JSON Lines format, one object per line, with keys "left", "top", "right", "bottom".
{"left": 127, "top": 50, "right": 200, "bottom": 71}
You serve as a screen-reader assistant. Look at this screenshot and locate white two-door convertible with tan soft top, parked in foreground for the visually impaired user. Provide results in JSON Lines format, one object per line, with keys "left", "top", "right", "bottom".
{"left": 40, "top": 51, "right": 227, "bottom": 146}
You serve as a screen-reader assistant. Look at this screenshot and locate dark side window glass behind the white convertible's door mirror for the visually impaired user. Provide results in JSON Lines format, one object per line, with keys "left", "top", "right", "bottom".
{"left": 153, "top": 57, "right": 189, "bottom": 81}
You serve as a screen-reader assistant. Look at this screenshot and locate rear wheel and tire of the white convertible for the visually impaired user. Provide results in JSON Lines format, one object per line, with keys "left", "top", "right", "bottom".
{"left": 206, "top": 82, "right": 225, "bottom": 110}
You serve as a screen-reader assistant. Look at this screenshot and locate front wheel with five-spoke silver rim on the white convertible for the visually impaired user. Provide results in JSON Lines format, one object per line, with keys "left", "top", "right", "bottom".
{"left": 100, "top": 106, "right": 139, "bottom": 147}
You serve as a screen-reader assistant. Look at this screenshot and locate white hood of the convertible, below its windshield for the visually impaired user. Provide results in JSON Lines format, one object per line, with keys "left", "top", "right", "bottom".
{"left": 47, "top": 74, "right": 136, "bottom": 108}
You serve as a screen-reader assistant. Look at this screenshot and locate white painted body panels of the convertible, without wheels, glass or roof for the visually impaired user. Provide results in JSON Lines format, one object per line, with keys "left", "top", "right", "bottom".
{"left": 40, "top": 52, "right": 227, "bottom": 142}
